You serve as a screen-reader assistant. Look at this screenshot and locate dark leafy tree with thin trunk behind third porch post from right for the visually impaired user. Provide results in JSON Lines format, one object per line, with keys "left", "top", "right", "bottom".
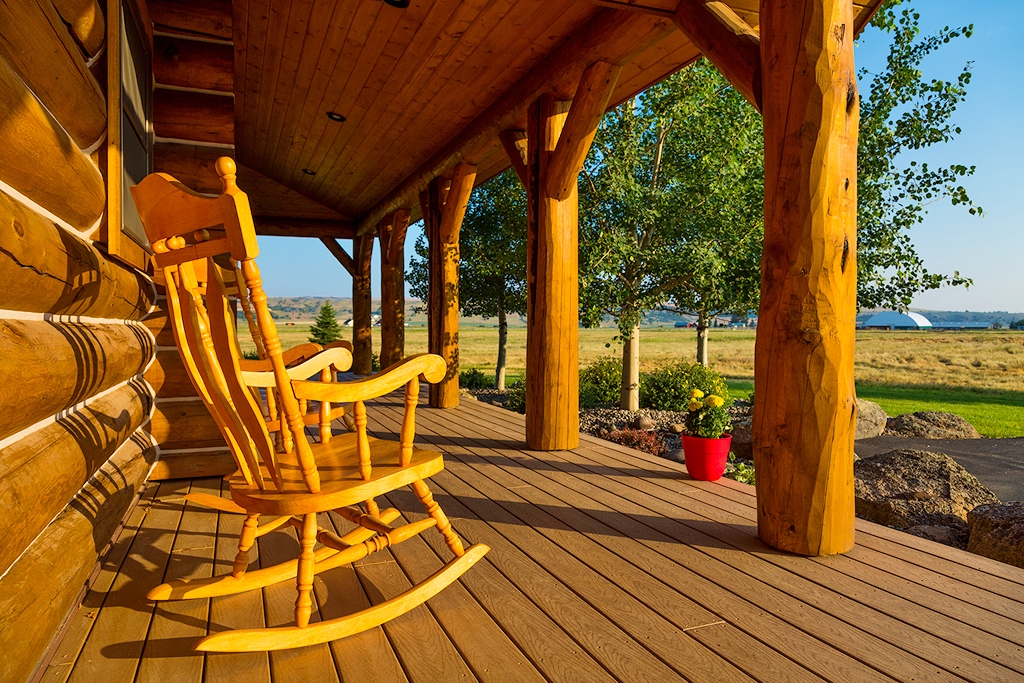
{"left": 408, "top": 169, "right": 526, "bottom": 389}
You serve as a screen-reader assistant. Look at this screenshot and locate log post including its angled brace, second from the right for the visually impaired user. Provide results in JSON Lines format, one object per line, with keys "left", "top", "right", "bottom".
{"left": 524, "top": 61, "right": 621, "bottom": 451}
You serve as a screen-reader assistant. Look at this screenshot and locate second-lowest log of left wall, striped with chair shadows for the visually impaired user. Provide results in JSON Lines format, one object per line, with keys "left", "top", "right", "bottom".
{"left": 0, "top": 382, "right": 153, "bottom": 574}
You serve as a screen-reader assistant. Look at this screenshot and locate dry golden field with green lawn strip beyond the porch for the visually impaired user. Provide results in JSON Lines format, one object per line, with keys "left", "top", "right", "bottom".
{"left": 239, "top": 323, "right": 1024, "bottom": 437}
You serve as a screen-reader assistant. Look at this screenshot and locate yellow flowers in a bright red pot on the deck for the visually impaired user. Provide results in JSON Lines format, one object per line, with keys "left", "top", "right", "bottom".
{"left": 683, "top": 389, "right": 732, "bottom": 481}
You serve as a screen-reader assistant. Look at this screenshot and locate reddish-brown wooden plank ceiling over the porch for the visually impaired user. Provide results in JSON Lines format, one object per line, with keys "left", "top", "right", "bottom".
{"left": 232, "top": 0, "right": 880, "bottom": 233}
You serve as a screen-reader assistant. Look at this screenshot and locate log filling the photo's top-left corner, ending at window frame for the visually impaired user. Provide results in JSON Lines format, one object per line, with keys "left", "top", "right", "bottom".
{"left": 0, "top": 0, "right": 106, "bottom": 150}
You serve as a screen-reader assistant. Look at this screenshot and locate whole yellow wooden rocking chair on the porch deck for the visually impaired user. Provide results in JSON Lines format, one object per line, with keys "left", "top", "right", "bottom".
{"left": 132, "top": 157, "right": 488, "bottom": 652}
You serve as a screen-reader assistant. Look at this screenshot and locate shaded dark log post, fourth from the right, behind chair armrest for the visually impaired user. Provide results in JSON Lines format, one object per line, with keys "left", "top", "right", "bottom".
{"left": 377, "top": 209, "right": 410, "bottom": 368}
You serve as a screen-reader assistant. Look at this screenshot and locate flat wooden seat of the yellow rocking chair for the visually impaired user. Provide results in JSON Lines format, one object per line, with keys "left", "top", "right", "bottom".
{"left": 228, "top": 434, "right": 444, "bottom": 515}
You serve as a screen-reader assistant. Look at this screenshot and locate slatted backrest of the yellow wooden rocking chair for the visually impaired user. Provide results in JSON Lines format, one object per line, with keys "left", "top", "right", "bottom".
{"left": 131, "top": 157, "right": 319, "bottom": 493}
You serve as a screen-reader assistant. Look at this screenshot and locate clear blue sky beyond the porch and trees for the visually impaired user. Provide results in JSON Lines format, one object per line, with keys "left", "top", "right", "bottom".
{"left": 251, "top": 0, "right": 1024, "bottom": 311}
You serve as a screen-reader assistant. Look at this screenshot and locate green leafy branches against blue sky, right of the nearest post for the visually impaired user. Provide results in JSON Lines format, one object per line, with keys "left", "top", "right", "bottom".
{"left": 857, "top": 0, "right": 982, "bottom": 311}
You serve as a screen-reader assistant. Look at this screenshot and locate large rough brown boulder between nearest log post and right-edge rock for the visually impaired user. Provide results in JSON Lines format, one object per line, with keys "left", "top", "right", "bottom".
{"left": 853, "top": 449, "right": 998, "bottom": 548}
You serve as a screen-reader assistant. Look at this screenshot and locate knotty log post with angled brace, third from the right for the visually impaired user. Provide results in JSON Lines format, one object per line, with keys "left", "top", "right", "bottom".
{"left": 420, "top": 164, "right": 476, "bottom": 408}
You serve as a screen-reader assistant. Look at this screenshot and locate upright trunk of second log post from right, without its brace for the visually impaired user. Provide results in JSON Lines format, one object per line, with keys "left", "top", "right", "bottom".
{"left": 526, "top": 95, "right": 580, "bottom": 451}
